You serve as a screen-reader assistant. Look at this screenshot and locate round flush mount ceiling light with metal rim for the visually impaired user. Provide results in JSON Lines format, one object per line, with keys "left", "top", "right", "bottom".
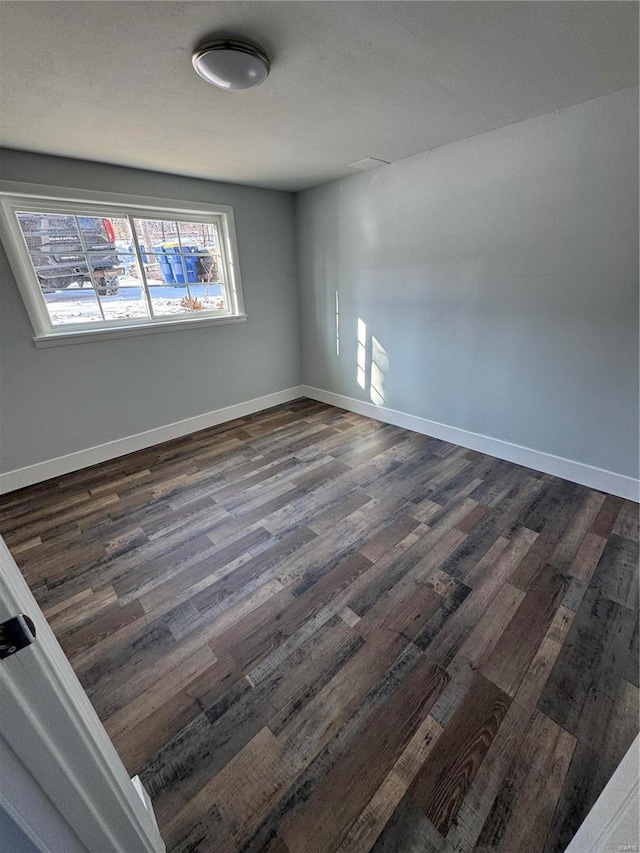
{"left": 193, "top": 39, "right": 271, "bottom": 92}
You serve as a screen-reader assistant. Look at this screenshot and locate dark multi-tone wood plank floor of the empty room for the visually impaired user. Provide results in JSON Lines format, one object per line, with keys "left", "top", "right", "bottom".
{"left": 0, "top": 400, "right": 638, "bottom": 853}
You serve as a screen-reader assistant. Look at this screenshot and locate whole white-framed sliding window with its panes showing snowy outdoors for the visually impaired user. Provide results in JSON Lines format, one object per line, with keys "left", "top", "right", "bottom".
{"left": 0, "top": 187, "right": 246, "bottom": 346}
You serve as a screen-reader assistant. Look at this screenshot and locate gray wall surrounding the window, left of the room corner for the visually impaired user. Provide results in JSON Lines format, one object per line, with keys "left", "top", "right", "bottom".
{"left": 0, "top": 147, "right": 300, "bottom": 471}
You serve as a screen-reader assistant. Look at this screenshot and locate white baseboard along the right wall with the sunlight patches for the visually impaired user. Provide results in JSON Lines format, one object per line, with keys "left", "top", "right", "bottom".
{"left": 302, "top": 385, "right": 640, "bottom": 503}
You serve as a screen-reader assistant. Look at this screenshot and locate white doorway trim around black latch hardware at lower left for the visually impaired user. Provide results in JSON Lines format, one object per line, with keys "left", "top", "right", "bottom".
{"left": 0, "top": 537, "right": 165, "bottom": 853}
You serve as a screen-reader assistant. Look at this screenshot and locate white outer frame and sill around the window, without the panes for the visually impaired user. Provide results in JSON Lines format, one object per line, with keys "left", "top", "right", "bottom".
{"left": 0, "top": 181, "right": 247, "bottom": 347}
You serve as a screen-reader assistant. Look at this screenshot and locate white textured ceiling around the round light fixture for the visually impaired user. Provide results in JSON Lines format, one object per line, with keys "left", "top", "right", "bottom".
{"left": 0, "top": 0, "right": 638, "bottom": 190}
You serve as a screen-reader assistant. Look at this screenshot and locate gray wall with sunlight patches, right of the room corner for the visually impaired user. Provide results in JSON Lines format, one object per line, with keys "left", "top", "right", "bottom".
{"left": 297, "top": 89, "right": 638, "bottom": 477}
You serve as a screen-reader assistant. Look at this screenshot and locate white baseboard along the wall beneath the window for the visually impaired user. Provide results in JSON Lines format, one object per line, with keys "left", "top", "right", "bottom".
{"left": 0, "top": 385, "right": 304, "bottom": 495}
